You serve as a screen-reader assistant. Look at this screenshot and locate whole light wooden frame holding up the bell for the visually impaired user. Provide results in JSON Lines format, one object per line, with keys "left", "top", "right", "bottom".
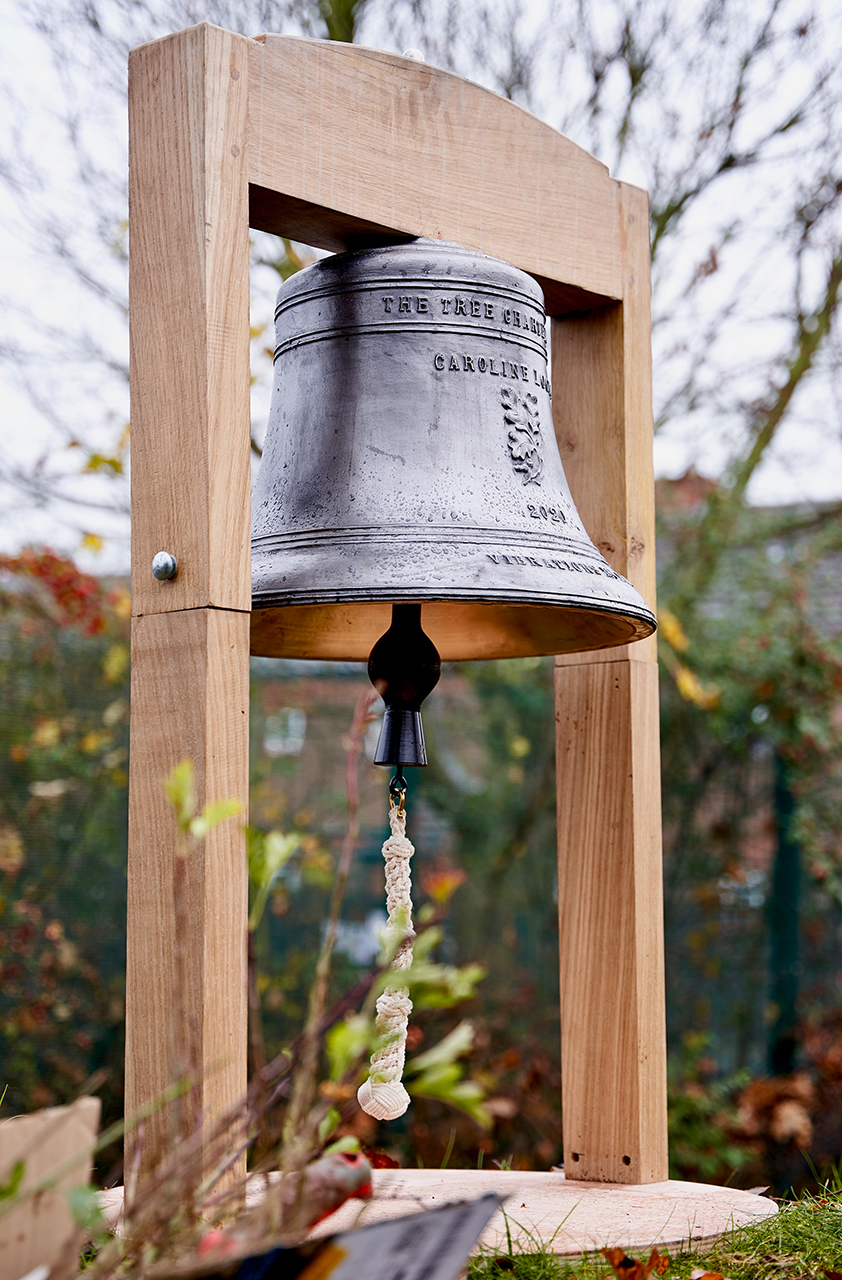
{"left": 125, "top": 24, "right": 667, "bottom": 1183}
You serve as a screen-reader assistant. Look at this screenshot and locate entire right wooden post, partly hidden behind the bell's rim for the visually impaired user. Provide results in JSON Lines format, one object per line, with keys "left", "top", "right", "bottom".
{"left": 553, "top": 184, "right": 668, "bottom": 1183}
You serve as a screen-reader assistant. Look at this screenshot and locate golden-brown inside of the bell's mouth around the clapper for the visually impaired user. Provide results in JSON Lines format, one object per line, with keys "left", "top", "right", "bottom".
{"left": 245, "top": 595, "right": 655, "bottom": 662}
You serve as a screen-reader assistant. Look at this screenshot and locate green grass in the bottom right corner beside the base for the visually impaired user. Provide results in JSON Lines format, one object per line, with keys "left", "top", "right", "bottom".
{"left": 468, "top": 1178, "right": 842, "bottom": 1280}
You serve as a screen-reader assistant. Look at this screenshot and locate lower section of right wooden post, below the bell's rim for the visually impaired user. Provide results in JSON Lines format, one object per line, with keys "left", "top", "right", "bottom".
{"left": 555, "top": 662, "right": 668, "bottom": 1183}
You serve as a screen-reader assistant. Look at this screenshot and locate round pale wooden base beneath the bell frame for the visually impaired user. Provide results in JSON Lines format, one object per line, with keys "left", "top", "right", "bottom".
{"left": 100, "top": 1169, "right": 778, "bottom": 1257}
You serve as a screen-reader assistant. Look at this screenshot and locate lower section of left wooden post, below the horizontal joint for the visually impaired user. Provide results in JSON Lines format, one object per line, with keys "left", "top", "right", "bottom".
{"left": 125, "top": 609, "right": 250, "bottom": 1164}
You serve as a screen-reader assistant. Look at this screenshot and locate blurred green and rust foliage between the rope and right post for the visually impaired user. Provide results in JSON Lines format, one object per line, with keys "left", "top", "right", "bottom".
{"left": 409, "top": 658, "right": 560, "bottom": 1169}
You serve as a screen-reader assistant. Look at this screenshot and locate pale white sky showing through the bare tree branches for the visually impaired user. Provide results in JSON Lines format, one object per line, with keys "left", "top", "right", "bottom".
{"left": 0, "top": 0, "right": 842, "bottom": 572}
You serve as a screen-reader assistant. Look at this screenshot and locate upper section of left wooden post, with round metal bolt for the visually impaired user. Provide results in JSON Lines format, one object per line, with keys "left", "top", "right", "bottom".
{"left": 129, "top": 26, "right": 251, "bottom": 614}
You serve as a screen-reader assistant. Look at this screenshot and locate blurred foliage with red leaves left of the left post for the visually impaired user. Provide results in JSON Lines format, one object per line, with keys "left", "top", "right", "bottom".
{"left": 0, "top": 552, "right": 128, "bottom": 1160}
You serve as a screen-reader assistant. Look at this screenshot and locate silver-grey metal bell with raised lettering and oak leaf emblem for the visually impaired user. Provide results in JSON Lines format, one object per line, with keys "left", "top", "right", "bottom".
{"left": 252, "top": 241, "right": 655, "bottom": 660}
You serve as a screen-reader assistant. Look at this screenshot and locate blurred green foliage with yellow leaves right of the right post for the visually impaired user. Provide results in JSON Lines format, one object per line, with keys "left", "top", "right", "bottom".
{"left": 659, "top": 491, "right": 842, "bottom": 1076}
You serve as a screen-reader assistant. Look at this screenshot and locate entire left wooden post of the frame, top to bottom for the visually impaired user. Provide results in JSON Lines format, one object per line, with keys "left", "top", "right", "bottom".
{"left": 125, "top": 26, "right": 251, "bottom": 1169}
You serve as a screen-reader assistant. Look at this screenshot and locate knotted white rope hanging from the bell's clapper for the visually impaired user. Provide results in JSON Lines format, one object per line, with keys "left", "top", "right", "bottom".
{"left": 357, "top": 805, "right": 415, "bottom": 1120}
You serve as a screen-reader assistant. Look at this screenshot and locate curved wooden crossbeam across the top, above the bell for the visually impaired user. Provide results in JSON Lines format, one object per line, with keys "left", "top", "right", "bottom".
{"left": 248, "top": 36, "right": 623, "bottom": 311}
